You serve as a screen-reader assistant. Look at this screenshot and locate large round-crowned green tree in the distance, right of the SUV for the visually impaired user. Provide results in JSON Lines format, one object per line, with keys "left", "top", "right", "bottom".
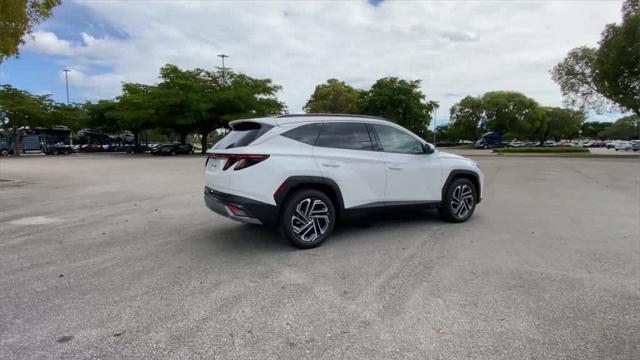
{"left": 481, "top": 91, "right": 544, "bottom": 138}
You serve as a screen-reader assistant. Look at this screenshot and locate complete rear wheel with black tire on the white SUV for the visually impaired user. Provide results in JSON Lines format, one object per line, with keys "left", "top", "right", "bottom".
{"left": 280, "top": 189, "right": 336, "bottom": 249}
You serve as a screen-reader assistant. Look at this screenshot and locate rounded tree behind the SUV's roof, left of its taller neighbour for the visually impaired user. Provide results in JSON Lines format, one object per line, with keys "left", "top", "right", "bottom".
{"left": 304, "top": 79, "right": 362, "bottom": 114}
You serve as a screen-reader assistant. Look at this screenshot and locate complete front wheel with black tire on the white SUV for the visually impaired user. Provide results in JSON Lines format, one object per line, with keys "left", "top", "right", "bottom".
{"left": 438, "top": 178, "right": 478, "bottom": 223}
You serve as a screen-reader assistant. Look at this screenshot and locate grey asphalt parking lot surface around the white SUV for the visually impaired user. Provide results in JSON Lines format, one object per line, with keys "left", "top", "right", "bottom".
{"left": 0, "top": 154, "right": 640, "bottom": 360}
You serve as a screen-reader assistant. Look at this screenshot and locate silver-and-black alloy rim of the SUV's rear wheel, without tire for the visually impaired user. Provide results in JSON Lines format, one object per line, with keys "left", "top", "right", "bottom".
{"left": 291, "top": 198, "right": 330, "bottom": 242}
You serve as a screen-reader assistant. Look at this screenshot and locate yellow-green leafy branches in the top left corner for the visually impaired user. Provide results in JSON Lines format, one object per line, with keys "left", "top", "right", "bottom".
{"left": 0, "top": 0, "right": 61, "bottom": 63}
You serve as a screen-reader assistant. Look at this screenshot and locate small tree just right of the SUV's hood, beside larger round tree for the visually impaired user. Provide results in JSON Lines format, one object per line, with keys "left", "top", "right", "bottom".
{"left": 450, "top": 96, "right": 486, "bottom": 141}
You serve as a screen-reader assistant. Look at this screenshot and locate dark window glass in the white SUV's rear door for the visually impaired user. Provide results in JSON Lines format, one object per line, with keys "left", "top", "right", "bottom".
{"left": 316, "top": 123, "right": 373, "bottom": 150}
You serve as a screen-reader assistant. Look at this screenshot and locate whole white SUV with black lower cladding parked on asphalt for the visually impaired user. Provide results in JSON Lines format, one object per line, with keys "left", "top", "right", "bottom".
{"left": 204, "top": 114, "right": 484, "bottom": 248}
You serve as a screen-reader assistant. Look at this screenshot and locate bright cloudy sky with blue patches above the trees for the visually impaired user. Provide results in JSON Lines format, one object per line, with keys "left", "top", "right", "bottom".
{"left": 0, "top": 0, "right": 621, "bottom": 123}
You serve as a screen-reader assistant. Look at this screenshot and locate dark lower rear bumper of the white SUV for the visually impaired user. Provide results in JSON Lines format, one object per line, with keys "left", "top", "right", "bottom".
{"left": 204, "top": 186, "right": 278, "bottom": 225}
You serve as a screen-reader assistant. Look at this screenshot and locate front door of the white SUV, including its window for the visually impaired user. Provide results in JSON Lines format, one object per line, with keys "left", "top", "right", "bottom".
{"left": 372, "top": 124, "right": 442, "bottom": 204}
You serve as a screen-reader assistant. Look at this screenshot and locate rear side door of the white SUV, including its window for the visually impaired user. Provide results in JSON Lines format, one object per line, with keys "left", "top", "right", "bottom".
{"left": 313, "top": 121, "right": 385, "bottom": 208}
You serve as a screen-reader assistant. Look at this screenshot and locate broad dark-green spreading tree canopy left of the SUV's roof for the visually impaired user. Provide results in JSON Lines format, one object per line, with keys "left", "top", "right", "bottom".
{"left": 91, "top": 64, "right": 284, "bottom": 151}
